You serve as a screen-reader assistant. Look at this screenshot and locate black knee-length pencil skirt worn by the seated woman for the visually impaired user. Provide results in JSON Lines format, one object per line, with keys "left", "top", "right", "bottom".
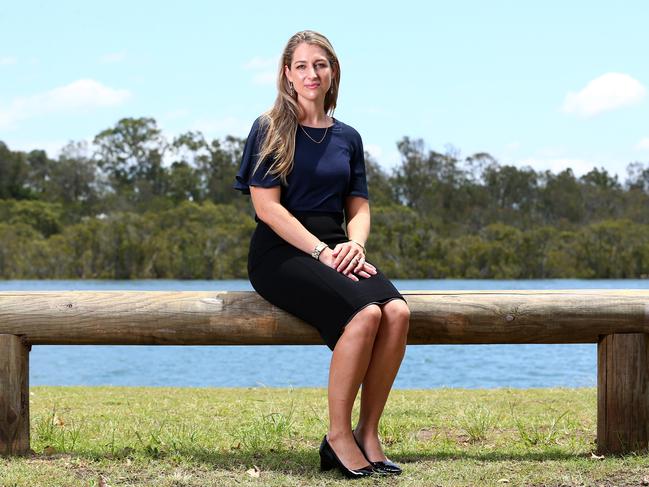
{"left": 248, "top": 212, "right": 406, "bottom": 350}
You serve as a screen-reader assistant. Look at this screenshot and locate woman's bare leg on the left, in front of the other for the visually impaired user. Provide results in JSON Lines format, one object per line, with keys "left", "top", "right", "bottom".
{"left": 327, "top": 304, "right": 381, "bottom": 469}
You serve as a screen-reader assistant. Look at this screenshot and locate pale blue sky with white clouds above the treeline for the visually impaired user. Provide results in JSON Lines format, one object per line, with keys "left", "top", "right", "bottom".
{"left": 0, "top": 0, "right": 649, "bottom": 182}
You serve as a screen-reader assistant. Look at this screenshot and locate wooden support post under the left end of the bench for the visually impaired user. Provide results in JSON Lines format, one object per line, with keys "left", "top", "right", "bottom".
{"left": 0, "top": 334, "right": 29, "bottom": 456}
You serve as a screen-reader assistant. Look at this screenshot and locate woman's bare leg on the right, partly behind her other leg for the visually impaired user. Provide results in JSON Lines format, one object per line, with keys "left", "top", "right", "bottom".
{"left": 354, "top": 299, "right": 410, "bottom": 462}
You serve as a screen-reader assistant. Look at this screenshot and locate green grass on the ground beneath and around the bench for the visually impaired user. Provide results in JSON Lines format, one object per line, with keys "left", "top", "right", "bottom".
{"left": 0, "top": 387, "right": 649, "bottom": 487}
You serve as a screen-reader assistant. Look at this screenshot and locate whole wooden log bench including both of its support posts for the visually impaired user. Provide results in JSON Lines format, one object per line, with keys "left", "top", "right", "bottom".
{"left": 0, "top": 289, "right": 649, "bottom": 455}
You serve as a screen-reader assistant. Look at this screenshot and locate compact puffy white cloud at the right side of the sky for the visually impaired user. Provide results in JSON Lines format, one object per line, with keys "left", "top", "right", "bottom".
{"left": 562, "top": 73, "right": 646, "bottom": 117}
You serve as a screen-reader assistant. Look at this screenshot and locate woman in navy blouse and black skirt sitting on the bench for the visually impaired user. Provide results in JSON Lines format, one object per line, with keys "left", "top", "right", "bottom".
{"left": 234, "top": 31, "right": 410, "bottom": 478}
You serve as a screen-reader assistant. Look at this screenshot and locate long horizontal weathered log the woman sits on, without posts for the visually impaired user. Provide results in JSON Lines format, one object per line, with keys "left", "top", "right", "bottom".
{"left": 0, "top": 290, "right": 649, "bottom": 345}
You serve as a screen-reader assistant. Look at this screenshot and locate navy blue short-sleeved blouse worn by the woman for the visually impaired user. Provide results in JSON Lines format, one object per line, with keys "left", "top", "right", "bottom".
{"left": 234, "top": 117, "right": 369, "bottom": 213}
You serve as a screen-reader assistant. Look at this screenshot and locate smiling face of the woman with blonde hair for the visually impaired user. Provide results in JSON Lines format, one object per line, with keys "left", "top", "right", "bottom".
{"left": 284, "top": 42, "right": 333, "bottom": 100}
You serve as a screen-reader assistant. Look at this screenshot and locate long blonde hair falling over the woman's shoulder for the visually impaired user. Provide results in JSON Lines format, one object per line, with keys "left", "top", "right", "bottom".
{"left": 253, "top": 30, "right": 340, "bottom": 184}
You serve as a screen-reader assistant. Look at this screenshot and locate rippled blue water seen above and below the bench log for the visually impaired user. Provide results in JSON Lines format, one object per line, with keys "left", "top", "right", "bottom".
{"left": 0, "top": 279, "right": 649, "bottom": 389}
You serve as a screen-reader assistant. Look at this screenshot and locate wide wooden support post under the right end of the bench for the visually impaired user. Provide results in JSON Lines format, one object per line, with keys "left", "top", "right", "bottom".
{"left": 597, "top": 333, "right": 649, "bottom": 454}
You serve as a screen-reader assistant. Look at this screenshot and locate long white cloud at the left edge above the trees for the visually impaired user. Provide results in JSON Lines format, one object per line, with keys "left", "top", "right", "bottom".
{"left": 0, "top": 79, "right": 131, "bottom": 127}
